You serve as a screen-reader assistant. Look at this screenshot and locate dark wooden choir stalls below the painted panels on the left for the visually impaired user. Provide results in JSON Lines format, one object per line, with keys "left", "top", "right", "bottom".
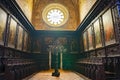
{"left": 0, "top": 46, "right": 46, "bottom": 80}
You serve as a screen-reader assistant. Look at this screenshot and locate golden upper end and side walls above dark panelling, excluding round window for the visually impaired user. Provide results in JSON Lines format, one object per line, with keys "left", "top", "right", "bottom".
{"left": 16, "top": 0, "right": 96, "bottom": 31}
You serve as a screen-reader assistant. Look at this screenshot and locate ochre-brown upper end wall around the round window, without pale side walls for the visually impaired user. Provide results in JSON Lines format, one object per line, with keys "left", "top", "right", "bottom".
{"left": 32, "top": 0, "right": 79, "bottom": 31}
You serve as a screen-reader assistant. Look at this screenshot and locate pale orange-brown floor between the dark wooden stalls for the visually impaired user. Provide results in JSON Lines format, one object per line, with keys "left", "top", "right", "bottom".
{"left": 23, "top": 70, "right": 89, "bottom": 80}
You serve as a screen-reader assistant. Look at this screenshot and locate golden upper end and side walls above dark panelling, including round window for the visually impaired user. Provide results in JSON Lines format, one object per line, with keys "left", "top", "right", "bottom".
{"left": 16, "top": 0, "right": 96, "bottom": 31}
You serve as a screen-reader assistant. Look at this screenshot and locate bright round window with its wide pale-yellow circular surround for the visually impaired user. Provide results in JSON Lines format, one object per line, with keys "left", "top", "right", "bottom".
{"left": 42, "top": 3, "right": 69, "bottom": 27}
